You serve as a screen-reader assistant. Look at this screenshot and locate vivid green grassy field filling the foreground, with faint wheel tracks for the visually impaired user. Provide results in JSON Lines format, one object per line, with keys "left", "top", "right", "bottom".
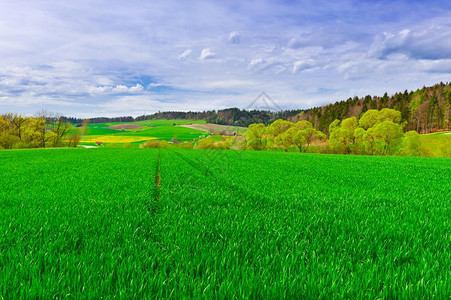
{"left": 0, "top": 149, "right": 451, "bottom": 299}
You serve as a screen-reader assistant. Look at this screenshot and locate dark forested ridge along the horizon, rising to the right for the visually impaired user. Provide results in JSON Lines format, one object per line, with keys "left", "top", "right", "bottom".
{"left": 67, "top": 82, "right": 451, "bottom": 133}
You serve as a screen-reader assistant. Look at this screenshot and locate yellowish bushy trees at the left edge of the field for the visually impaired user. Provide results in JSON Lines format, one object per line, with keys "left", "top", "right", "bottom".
{"left": 0, "top": 111, "right": 88, "bottom": 149}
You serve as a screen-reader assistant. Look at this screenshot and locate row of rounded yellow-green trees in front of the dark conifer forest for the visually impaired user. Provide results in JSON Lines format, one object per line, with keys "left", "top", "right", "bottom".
{"left": 246, "top": 108, "right": 421, "bottom": 156}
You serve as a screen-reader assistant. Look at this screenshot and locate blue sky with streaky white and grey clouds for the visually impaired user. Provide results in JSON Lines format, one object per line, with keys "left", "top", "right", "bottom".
{"left": 0, "top": 0, "right": 451, "bottom": 118}
